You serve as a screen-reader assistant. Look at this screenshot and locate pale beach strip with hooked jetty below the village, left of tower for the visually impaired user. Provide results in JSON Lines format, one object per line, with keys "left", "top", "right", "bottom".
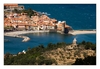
{"left": 4, "top": 30, "right": 49, "bottom": 42}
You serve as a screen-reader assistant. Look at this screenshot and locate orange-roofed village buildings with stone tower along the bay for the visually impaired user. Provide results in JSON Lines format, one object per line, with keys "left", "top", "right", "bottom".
{"left": 4, "top": 4, "right": 72, "bottom": 33}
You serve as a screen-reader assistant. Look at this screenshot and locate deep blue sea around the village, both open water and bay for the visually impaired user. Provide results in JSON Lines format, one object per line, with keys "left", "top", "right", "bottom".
{"left": 4, "top": 4, "right": 96, "bottom": 54}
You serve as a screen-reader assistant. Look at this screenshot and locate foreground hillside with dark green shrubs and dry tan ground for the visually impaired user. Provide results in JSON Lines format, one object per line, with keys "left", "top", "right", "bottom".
{"left": 4, "top": 41, "right": 96, "bottom": 65}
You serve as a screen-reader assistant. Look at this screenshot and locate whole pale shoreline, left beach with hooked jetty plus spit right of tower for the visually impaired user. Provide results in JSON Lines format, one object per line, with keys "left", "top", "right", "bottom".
{"left": 4, "top": 30, "right": 96, "bottom": 42}
